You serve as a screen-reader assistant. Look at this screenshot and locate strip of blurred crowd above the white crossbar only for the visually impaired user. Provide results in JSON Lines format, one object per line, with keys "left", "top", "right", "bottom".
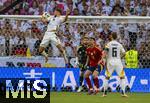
{"left": 0, "top": 0, "right": 150, "bottom": 16}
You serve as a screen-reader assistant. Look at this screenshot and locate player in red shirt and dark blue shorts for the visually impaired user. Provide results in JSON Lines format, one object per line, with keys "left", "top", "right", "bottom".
{"left": 84, "top": 38, "right": 103, "bottom": 95}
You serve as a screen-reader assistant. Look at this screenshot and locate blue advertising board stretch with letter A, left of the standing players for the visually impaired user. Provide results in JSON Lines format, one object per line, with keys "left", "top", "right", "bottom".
{"left": 0, "top": 67, "right": 79, "bottom": 90}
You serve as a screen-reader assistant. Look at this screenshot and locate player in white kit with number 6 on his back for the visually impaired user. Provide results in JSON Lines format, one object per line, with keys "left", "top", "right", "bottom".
{"left": 103, "top": 32, "right": 127, "bottom": 97}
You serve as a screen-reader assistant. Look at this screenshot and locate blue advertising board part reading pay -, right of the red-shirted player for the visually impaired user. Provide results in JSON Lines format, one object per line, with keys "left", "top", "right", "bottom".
{"left": 99, "top": 69, "right": 150, "bottom": 92}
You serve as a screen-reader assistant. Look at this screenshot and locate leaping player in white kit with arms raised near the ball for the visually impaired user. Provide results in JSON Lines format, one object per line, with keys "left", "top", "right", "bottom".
{"left": 39, "top": 8, "right": 70, "bottom": 66}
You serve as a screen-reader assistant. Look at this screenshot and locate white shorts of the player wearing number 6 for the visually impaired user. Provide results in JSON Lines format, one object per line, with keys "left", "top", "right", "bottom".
{"left": 105, "top": 60, "right": 125, "bottom": 77}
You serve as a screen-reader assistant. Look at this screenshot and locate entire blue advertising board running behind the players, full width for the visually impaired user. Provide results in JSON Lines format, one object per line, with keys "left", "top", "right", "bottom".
{"left": 0, "top": 67, "right": 150, "bottom": 92}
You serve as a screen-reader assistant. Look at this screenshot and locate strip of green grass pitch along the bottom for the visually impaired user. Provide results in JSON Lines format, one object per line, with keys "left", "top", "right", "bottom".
{"left": 50, "top": 92, "right": 150, "bottom": 103}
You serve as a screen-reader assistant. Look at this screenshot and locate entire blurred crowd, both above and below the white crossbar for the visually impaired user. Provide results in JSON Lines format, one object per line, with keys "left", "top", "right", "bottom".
{"left": 0, "top": 0, "right": 150, "bottom": 68}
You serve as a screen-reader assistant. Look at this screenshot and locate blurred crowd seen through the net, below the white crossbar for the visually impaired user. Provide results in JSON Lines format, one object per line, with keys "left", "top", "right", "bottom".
{"left": 0, "top": 20, "right": 150, "bottom": 68}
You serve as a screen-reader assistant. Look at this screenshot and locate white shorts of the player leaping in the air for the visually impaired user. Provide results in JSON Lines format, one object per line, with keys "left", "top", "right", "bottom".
{"left": 40, "top": 32, "right": 61, "bottom": 47}
